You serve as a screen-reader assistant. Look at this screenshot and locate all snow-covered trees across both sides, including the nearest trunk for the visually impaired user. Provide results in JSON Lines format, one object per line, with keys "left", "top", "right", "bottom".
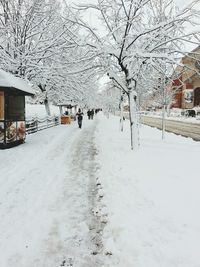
{"left": 0, "top": 0, "right": 200, "bottom": 149}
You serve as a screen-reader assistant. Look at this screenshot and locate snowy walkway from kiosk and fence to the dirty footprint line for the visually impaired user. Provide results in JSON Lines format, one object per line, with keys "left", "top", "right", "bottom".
{"left": 0, "top": 121, "right": 106, "bottom": 267}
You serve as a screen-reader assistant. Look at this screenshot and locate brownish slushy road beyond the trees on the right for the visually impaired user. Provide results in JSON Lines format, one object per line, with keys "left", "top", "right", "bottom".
{"left": 142, "top": 116, "right": 200, "bottom": 141}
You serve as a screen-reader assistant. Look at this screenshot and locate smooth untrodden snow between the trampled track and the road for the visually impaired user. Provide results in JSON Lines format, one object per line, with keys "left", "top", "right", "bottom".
{"left": 96, "top": 117, "right": 200, "bottom": 267}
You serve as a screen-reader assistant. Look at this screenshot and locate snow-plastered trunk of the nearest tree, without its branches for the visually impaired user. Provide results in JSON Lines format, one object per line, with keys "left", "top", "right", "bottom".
{"left": 128, "top": 90, "right": 139, "bottom": 150}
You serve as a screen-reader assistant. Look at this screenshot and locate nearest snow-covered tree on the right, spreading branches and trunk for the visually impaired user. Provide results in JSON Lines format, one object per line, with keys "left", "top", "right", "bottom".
{"left": 66, "top": 0, "right": 200, "bottom": 149}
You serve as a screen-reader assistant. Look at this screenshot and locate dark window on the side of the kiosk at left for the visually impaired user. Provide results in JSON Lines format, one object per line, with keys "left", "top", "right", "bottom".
{"left": 7, "top": 96, "right": 25, "bottom": 121}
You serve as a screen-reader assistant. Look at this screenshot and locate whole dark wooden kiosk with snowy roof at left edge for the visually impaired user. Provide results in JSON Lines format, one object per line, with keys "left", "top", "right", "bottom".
{"left": 0, "top": 70, "right": 34, "bottom": 149}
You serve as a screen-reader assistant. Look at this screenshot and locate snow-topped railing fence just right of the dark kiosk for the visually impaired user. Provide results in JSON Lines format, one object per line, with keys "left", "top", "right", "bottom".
{"left": 26, "top": 116, "right": 60, "bottom": 134}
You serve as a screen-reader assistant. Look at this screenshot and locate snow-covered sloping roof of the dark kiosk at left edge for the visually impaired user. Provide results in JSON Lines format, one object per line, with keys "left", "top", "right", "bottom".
{"left": 0, "top": 69, "right": 35, "bottom": 95}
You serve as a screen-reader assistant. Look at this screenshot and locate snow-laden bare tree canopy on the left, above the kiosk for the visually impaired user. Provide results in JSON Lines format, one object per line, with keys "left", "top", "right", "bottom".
{"left": 0, "top": 0, "right": 100, "bottom": 112}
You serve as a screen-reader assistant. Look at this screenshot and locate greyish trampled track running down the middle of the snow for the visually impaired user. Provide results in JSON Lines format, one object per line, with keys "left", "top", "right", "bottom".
{"left": 60, "top": 120, "right": 106, "bottom": 267}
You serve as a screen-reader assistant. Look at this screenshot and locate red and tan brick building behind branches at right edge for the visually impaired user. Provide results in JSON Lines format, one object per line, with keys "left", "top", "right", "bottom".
{"left": 172, "top": 46, "right": 200, "bottom": 109}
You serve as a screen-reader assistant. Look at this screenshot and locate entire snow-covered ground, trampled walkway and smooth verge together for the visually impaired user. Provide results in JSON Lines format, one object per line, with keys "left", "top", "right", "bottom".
{"left": 0, "top": 109, "right": 200, "bottom": 267}
